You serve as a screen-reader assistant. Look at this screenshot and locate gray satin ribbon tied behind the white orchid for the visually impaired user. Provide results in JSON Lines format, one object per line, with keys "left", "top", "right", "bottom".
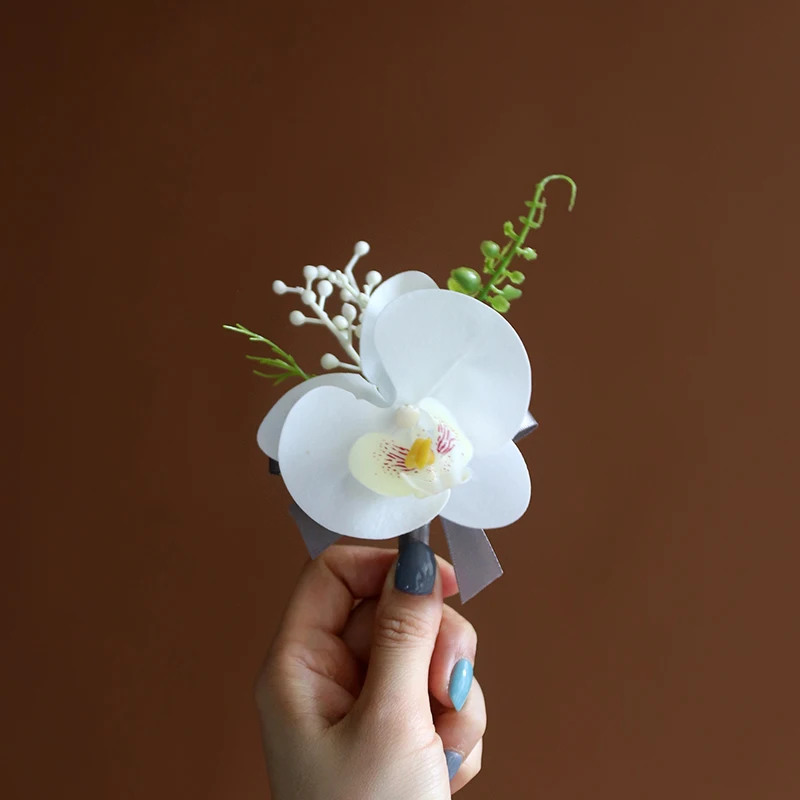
{"left": 270, "top": 410, "right": 539, "bottom": 603}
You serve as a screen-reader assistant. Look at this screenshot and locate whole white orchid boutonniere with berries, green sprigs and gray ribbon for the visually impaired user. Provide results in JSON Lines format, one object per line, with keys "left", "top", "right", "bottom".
{"left": 225, "top": 175, "right": 576, "bottom": 601}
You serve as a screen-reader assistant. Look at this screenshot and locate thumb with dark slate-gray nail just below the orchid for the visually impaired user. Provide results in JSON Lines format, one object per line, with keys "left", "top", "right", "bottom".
{"left": 359, "top": 534, "right": 442, "bottom": 715}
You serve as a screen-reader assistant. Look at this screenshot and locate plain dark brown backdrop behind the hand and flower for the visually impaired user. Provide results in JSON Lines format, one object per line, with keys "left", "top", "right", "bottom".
{"left": 2, "top": 0, "right": 800, "bottom": 800}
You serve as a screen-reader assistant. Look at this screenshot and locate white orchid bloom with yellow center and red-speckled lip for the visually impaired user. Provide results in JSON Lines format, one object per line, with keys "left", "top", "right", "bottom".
{"left": 258, "top": 272, "right": 531, "bottom": 539}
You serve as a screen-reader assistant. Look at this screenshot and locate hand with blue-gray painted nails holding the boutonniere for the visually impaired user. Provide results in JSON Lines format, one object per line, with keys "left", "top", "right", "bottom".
{"left": 256, "top": 538, "right": 486, "bottom": 800}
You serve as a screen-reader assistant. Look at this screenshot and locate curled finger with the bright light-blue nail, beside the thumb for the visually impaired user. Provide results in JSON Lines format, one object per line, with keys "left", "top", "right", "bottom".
{"left": 429, "top": 606, "right": 478, "bottom": 711}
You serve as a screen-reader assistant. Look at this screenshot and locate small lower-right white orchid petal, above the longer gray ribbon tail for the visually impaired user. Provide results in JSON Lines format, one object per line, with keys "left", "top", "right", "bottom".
{"left": 442, "top": 442, "right": 531, "bottom": 528}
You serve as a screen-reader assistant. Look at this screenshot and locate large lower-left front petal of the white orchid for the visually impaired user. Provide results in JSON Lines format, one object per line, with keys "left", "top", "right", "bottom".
{"left": 278, "top": 386, "right": 450, "bottom": 539}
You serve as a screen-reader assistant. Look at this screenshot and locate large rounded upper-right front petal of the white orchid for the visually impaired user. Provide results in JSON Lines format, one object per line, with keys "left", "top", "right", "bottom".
{"left": 375, "top": 290, "right": 531, "bottom": 453}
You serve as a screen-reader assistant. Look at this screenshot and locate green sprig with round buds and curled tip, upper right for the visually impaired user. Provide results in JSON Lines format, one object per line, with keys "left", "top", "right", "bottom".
{"left": 447, "top": 175, "right": 578, "bottom": 314}
